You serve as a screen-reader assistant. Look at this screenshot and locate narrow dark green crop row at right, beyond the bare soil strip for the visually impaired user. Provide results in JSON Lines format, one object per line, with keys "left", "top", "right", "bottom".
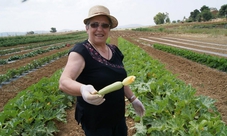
{"left": 153, "top": 44, "right": 227, "bottom": 72}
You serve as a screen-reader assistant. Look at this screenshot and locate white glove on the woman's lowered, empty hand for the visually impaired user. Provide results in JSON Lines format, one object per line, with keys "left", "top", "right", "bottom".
{"left": 132, "top": 98, "right": 145, "bottom": 117}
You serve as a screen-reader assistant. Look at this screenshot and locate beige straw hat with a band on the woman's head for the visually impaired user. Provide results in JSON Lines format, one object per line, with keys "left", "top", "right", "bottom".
{"left": 84, "top": 5, "right": 118, "bottom": 29}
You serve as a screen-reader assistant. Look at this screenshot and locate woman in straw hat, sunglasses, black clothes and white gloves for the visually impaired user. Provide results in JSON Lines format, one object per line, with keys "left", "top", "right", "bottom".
{"left": 59, "top": 5, "right": 145, "bottom": 136}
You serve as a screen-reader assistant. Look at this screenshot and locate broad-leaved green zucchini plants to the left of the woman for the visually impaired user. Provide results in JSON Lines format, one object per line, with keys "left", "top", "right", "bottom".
{"left": 0, "top": 70, "right": 75, "bottom": 136}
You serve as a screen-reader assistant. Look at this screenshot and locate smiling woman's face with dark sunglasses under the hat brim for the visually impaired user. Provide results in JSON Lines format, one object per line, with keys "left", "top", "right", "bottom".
{"left": 86, "top": 16, "right": 110, "bottom": 45}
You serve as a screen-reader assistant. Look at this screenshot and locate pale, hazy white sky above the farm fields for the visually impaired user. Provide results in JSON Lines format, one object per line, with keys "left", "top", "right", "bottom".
{"left": 0, "top": 0, "right": 227, "bottom": 32}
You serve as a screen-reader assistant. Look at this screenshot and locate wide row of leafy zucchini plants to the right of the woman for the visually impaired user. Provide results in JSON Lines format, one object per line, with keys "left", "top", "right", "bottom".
{"left": 118, "top": 38, "right": 227, "bottom": 136}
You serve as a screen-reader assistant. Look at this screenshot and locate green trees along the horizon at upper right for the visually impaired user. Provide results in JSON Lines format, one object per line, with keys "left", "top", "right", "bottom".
{"left": 153, "top": 4, "right": 227, "bottom": 25}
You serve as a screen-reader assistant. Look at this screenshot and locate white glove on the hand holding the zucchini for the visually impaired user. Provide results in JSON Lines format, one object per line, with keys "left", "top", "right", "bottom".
{"left": 80, "top": 85, "right": 105, "bottom": 105}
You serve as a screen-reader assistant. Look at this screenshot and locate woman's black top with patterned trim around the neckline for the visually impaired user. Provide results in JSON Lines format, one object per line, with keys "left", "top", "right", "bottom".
{"left": 70, "top": 40, "right": 127, "bottom": 129}
